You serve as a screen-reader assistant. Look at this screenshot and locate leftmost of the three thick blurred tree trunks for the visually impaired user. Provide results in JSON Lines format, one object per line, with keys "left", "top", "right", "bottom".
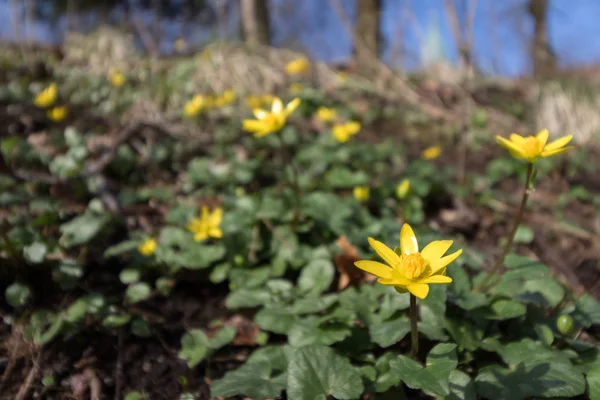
{"left": 239, "top": 0, "right": 271, "bottom": 46}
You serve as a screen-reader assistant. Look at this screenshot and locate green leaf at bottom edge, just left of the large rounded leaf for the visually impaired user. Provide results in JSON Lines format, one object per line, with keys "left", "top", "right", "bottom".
{"left": 210, "top": 361, "right": 287, "bottom": 399}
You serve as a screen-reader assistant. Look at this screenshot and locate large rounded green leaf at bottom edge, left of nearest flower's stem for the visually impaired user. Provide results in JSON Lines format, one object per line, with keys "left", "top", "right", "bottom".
{"left": 287, "top": 346, "right": 363, "bottom": 400}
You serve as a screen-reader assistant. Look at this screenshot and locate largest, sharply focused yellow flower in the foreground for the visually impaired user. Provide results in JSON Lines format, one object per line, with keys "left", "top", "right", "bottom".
{"left": 354, "top": 224, "right": 462, "bottom": 299}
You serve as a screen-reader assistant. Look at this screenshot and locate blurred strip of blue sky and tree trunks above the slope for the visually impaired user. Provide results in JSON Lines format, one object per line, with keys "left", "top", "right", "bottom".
{"left": 0, "top": 0, "right": 600, "bottom": 76}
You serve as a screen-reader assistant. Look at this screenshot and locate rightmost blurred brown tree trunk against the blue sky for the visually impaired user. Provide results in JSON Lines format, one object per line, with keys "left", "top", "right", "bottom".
{"left": 528, "top": 0, "right": 556, "bottom": 78}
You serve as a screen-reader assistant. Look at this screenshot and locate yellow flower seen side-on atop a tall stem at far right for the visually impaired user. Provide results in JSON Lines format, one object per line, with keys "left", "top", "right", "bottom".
{"left": 496, "top": 129, "right": 573, "bottom": 163}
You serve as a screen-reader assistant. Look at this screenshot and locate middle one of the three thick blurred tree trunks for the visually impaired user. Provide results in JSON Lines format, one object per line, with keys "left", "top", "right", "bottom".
{"left": 354, "top": 0, "right": 382, "bottom": 70}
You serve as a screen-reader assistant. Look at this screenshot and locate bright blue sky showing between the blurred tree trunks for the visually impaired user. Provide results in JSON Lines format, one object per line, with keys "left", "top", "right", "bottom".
{"left": 0, "top": 0, "right": 600, "bottom": 75}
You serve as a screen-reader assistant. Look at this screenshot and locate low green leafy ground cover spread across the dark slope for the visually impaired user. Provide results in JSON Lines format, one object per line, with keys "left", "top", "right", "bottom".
{"left": 0, "top": 54, "right": 600, "bottom": 400}
